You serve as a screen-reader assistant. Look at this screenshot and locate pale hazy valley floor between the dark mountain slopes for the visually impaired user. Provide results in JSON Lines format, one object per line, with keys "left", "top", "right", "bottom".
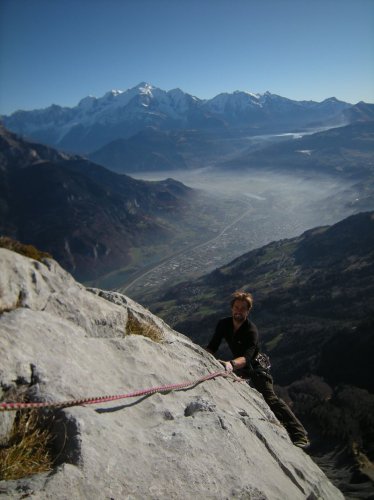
{"left": 120, "top": 167, "right": 373, "bottom": 298}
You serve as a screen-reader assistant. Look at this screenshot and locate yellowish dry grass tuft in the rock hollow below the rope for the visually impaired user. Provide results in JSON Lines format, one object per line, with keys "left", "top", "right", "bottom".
{"left": 0, "top": 410, "right": 53, "bottom": 481}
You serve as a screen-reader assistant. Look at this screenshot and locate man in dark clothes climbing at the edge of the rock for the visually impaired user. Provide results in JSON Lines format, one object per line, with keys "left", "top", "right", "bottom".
{"left": 206, "top": 291, "right": 310, "bottom": 449}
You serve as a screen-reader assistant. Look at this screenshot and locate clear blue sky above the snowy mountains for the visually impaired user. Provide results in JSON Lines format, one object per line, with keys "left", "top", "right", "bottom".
{"left": 0, "top": 0, "right": 374, "bottom": 114}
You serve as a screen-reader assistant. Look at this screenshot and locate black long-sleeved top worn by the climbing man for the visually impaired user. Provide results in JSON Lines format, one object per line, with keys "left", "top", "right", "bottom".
{"left": 207, "top": 316, "right": 259, "bottom": 375}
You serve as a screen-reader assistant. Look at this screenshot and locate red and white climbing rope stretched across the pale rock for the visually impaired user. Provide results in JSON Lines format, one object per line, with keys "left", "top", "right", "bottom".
{"left": 0, "top": 370, "right": 236, "bottom": 411}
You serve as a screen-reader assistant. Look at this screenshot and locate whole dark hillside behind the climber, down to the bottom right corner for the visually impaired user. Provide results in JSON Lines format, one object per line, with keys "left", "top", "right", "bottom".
{"left": 148, "top": 212, "right": 374, "bottom": 492}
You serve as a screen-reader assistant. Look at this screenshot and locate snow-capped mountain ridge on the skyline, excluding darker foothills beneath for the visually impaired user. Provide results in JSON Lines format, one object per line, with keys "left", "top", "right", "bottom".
{"left": 2, "top": 82, "right": 360, "bottom": 154}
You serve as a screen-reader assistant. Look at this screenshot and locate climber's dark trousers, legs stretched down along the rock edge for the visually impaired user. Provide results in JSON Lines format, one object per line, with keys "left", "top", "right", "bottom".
{"left": 248, "top": 370, "right": 307, "bottom": 441}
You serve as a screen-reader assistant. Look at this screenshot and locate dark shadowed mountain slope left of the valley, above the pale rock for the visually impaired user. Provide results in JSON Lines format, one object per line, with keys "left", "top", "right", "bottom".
{"left": 0, "top": 125, "right": 193, "bottom": 279}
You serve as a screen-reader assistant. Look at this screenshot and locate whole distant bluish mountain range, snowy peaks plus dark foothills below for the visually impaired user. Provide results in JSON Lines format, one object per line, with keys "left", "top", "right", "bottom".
{"left": 1, "top": 82, "right": 374, "bottom": 172}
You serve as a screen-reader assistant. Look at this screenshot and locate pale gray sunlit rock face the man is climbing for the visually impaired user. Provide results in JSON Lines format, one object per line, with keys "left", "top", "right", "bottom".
{"left": 0, "top": 249, "right": 343, "bottom": 500}
